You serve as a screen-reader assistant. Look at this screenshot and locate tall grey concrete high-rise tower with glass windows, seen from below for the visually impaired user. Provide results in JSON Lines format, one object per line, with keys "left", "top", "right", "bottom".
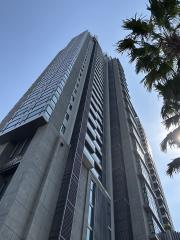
{"left": 0, "top": 31, "right": 173, "bottom": 240}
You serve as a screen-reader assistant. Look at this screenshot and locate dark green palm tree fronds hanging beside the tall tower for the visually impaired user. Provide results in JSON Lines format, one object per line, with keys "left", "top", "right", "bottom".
{"left": 117, "top": 0, "right": 180, "bottom": 176}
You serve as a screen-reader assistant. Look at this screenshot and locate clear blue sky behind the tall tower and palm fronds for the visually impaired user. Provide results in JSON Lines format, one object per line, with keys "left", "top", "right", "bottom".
{"left": 0, "top": 0, "right": 180, "bottom": 231}
